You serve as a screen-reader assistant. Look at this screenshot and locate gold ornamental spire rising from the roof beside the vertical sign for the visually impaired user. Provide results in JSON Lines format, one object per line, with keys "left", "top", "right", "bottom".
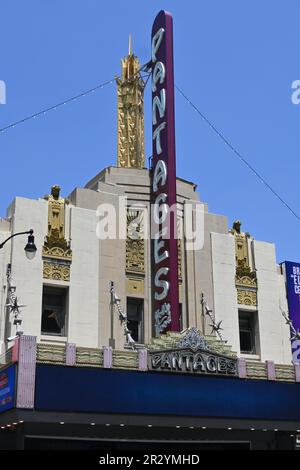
{"left": 116, "top": 34, "right": 145, "bottom": 168}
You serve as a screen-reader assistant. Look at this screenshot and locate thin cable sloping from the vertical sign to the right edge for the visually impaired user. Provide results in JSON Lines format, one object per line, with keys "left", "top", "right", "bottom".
{"left": 175, "top": 85, "right": 300, "bottom": 222}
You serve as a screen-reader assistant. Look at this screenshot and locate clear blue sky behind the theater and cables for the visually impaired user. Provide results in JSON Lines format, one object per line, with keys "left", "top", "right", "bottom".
{"left": 0, "top": 0, "right": 300, "bottom": 262}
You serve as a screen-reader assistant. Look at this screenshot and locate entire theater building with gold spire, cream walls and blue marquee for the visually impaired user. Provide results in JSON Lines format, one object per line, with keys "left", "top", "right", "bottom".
{"left": 0, "top": 10, "right": 300, "bottom": 450}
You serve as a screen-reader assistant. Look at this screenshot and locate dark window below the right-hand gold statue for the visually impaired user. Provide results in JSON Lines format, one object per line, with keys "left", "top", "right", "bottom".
{"left": 239, "top": 310, "right": 258, "bottom": 354}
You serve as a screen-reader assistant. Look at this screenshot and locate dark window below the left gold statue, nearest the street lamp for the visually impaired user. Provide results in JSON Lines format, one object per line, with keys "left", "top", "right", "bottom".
{"left": 41, "top": 286, "right": 68, "bottom": 336}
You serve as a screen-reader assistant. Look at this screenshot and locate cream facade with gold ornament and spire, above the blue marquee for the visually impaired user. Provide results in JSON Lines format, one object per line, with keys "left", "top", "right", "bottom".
{"left": 0, "top": 41, "right": 300, "bottom": 452}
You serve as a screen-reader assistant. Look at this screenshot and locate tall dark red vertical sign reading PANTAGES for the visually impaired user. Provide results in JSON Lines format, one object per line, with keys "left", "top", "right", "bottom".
{"left": 151, "top": 11, "right": 179, "bottom": 335}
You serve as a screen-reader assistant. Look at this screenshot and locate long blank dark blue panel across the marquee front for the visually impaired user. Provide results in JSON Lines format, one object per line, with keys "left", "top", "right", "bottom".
{"left": 35, "top": 364, "right": 300, "bottom": 421}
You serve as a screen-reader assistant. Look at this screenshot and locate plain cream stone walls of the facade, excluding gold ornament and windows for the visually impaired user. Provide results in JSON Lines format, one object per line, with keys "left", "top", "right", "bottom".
{"left": 0, "top": 167, "right": 291, "bottom": 364}
